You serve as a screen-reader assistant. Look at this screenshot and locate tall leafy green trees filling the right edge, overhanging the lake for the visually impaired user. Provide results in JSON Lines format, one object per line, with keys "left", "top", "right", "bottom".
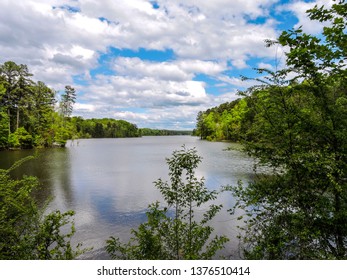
{"left": 232, "top": 1, "right": 347, "bottom": 259}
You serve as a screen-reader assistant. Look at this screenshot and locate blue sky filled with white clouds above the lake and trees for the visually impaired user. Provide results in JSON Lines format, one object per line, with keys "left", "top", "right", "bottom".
{"left": 0, "top": 0, "right": 332, "bottom": 129}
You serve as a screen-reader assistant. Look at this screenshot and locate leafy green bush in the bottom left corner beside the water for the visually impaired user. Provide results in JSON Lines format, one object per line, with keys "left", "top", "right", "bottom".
{"left": 0, "top": 157, "right": 85, "bottom": 260}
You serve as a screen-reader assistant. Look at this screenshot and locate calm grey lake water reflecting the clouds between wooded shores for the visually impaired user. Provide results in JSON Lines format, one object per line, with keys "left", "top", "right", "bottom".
{"left": 0, "top": 136, "right": 254, "bottom": 259}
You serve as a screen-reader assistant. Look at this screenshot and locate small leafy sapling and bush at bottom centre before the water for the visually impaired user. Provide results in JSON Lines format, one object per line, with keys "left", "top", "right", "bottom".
{"left": 106, "top": 147, "right": 228, "bottom": 259}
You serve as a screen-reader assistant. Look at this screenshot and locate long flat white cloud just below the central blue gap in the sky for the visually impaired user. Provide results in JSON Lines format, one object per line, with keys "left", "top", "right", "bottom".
{"left": 84, "top": 76, "right": 208, "bottom": 108}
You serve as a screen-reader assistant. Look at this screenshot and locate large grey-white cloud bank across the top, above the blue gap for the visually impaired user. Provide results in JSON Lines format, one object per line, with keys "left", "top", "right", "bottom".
{"left": 0, "top": 0, "right": 276, "bottom": 82}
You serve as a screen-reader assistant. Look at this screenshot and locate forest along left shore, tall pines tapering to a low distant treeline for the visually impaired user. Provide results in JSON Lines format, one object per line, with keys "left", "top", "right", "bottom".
{"left": 0, "top": 61, "right": 141, "bottom": 150}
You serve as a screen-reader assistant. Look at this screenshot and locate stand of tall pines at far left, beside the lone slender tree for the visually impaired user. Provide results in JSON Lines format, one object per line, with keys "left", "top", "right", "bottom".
{"left": 0, "top": 61, "right": 62, "bottom": 148}
